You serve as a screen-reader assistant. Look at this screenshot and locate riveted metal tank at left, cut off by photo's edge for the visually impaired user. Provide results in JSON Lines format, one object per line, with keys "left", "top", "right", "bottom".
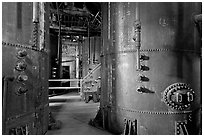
{"left": 2, "top": 2, "right": 49, "bottom": 135}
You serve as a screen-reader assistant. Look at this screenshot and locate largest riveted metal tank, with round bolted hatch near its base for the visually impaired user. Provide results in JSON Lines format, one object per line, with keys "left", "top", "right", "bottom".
{"left": 101, "top": 2, "right": 201, "bottom": 135}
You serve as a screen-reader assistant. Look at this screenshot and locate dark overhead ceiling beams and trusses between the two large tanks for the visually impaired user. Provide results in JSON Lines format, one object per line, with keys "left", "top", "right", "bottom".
{"left": 50, "top": 2, "right": 102, "bottom": 37}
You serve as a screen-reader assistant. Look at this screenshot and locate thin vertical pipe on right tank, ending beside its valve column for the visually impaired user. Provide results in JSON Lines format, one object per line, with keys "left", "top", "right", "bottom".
{"left": 133, "top": 3, "right": 141, "bottom": 70}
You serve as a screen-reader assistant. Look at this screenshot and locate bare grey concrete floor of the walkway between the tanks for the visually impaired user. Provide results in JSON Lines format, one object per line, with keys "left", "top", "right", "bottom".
{"left": 47, "top": 93, "right": 111, "bottom": 135}
